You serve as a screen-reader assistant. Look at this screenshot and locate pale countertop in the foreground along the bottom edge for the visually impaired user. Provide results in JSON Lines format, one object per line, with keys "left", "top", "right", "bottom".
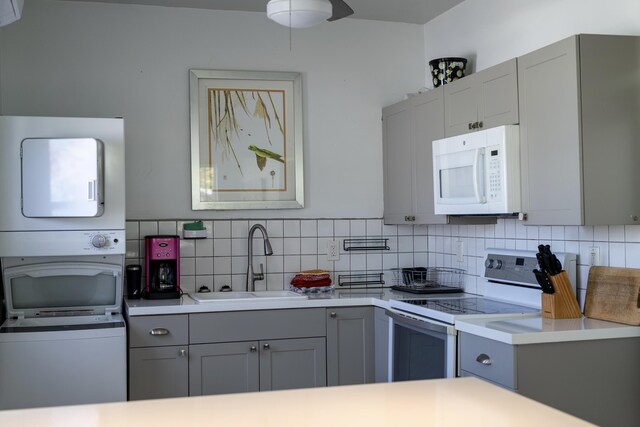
{"left": 0, "top": 378, "right": 591, "bottom": 427}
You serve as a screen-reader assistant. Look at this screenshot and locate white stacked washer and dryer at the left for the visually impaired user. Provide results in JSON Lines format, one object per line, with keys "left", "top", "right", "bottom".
{"left": 0, "top": 116, "right": 127, "bottom": 409}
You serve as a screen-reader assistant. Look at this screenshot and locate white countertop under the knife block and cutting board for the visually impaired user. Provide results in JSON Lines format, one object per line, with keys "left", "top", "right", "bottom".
{"left": 456, "top": 316, "right": 640, "bottom": 344}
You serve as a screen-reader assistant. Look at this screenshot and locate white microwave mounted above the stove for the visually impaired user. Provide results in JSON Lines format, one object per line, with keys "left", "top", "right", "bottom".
{"left": 433, "top": 125, "right": 521, "bottom": 215}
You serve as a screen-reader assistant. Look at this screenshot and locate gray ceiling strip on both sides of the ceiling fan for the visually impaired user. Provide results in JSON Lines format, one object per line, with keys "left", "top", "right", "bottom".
{"left": 57, "top": 0, "right": 464, "bottom": 24}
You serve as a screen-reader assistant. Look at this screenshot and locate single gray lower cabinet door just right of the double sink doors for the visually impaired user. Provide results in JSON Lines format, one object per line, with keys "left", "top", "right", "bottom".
{"left": 327, "top": 307, "right": 375, "bottom": 386}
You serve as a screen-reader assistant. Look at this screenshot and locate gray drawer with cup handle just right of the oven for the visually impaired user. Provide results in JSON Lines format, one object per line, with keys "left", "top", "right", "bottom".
{"left": 459, "top": 332, "right": 517, "bottom": 389}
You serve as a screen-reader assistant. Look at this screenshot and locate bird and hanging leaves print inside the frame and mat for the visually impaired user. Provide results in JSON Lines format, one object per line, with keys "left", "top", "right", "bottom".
{"left": 203, "top": 87, "right": 287, "bottom": 194}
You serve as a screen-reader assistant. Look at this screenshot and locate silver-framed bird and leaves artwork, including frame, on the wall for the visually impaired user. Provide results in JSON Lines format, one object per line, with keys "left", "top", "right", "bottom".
{"left": 189, "top": 70, "right": 304, "bottom": 210}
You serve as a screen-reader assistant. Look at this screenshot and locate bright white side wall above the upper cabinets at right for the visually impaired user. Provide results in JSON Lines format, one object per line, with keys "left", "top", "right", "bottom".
{"left": 424, "top": 0, "right": 640, "bottom": 77}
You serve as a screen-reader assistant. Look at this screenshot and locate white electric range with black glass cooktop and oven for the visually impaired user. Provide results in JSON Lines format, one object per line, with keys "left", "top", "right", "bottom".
{"left": 386, "top": 249, "right": 576, "bottom": 381}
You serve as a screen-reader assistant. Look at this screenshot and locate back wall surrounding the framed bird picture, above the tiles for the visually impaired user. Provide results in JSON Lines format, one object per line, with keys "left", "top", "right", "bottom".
{"left": 0, "top": 0, "right": 425, "bottom": 219}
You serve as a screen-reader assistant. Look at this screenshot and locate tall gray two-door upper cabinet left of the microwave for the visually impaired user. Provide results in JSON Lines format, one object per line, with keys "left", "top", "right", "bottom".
{"left": 382, "top": 88, "right": 447, "bottom": 224}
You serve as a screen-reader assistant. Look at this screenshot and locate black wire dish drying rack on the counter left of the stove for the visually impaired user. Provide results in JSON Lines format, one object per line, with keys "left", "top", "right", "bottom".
{"left": 391, "top": 267, "right": 466, "bottom": 293}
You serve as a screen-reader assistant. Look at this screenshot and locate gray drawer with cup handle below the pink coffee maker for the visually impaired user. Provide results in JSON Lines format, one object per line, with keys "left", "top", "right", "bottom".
{"left": 129, "top": 314, "right": 189, "bottom": 347}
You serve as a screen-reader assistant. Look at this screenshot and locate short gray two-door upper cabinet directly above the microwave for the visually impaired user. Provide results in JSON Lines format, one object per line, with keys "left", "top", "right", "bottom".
{"left": 443, "top": 59, "right": 519, "bottom": 137}
